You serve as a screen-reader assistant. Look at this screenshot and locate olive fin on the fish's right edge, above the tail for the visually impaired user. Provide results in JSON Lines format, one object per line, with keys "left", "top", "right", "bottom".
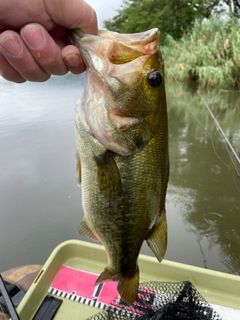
{"left": 146, "top": 211, "right": 167, "bottom": 262}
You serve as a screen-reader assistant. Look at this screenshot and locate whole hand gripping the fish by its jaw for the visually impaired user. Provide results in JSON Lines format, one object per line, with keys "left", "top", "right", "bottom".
{"left": 0, "top": 0, "right": 97, "bottom": 83}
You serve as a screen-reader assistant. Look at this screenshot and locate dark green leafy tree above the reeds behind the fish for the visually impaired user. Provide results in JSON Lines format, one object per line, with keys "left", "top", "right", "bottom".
{"left": 104, "top": 0, "right": 240, "bottom": 43}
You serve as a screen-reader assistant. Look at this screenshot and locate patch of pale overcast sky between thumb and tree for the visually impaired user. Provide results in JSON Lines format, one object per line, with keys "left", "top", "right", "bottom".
{"left": 86, "top": 0, "right": 122, "bottom": 29}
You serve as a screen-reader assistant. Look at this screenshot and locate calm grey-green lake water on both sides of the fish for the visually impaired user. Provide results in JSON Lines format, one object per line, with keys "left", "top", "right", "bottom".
{"left": 0, "top": 74, "right": 240, "bottom": 274}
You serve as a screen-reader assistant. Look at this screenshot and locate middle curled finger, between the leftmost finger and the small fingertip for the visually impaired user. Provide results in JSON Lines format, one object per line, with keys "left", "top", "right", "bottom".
{"left": 20, "top": 23, "right": 68, "bottom": 75}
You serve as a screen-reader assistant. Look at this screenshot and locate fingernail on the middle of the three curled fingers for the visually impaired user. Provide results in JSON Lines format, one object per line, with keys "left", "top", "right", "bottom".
{"left": 21, "top": 24, "right": 45, "bottom": 50}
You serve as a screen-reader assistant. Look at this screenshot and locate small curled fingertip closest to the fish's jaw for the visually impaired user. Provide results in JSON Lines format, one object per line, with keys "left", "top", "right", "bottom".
{"left": 62, "top": 45, "right": 86, "bottom": 74}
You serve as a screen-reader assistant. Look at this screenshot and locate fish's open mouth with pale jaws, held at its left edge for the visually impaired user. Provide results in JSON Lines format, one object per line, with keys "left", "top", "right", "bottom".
{"left": 69, "top": 28, "right": 160, "bottom": 74}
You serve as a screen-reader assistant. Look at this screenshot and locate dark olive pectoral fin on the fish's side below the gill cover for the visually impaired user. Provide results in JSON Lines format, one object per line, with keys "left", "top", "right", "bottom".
{"left": 94, "top": 151, "right": 122, "bottom": 198}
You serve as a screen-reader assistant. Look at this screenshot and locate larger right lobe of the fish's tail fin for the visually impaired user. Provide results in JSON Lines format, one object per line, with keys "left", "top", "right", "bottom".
{"left": 117, "top": 267, "right": 139, "bottom": 304}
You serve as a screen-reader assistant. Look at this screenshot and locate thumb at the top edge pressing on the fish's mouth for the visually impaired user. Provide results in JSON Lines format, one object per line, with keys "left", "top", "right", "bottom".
{"left": 44, "top": 0, "right": 98, "bottom": 34}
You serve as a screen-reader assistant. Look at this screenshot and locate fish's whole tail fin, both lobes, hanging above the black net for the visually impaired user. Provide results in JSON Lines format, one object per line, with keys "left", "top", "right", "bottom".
{"left": 95, "top": 267, "right": 139, "bottom": 304}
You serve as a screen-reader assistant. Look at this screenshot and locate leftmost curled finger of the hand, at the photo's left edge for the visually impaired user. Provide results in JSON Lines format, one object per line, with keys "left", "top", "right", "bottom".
{"left": 0, "top": 31, "right": 50, "bottom": 81}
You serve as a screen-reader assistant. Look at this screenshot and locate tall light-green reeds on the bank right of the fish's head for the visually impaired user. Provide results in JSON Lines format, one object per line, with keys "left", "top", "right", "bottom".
{"left": 161, "top": 18, "right": 240, "bottom": 88}
